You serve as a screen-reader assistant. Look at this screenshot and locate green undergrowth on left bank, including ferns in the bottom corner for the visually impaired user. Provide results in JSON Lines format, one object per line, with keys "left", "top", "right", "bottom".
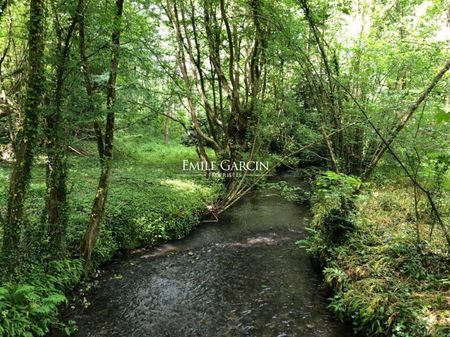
{"left": 0, "top": 136, "right": 221, "bottom": 337}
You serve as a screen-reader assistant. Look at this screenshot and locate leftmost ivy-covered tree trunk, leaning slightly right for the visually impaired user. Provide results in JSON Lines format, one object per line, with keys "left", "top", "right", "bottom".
{"left": 3, "top": 0, "right": 45, "bottom": 267}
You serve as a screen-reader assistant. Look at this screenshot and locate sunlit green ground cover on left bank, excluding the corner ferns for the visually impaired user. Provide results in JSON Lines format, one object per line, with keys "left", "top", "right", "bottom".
{"left": 0, "top": 135, "right": 220, "bottom": 265}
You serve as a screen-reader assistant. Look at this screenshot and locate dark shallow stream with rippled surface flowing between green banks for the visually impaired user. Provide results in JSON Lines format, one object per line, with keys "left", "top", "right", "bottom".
{"left": 59, "top": 175, "right": 353, "bottom": 337}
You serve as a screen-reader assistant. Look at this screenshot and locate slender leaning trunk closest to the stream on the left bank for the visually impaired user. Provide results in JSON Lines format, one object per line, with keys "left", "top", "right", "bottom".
{"left": 81, "top": 0, "right": 124, "bottom": 269}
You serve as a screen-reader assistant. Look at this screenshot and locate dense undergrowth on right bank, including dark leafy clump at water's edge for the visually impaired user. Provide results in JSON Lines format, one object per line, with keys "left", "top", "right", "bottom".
{"left": 299, "top": 172, "right": 450, "bottom": 337}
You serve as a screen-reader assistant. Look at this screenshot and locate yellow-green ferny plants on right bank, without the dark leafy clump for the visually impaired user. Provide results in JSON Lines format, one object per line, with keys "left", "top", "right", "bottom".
{"left": 301, "top": 182, "right": 450, "bottom": 337}
